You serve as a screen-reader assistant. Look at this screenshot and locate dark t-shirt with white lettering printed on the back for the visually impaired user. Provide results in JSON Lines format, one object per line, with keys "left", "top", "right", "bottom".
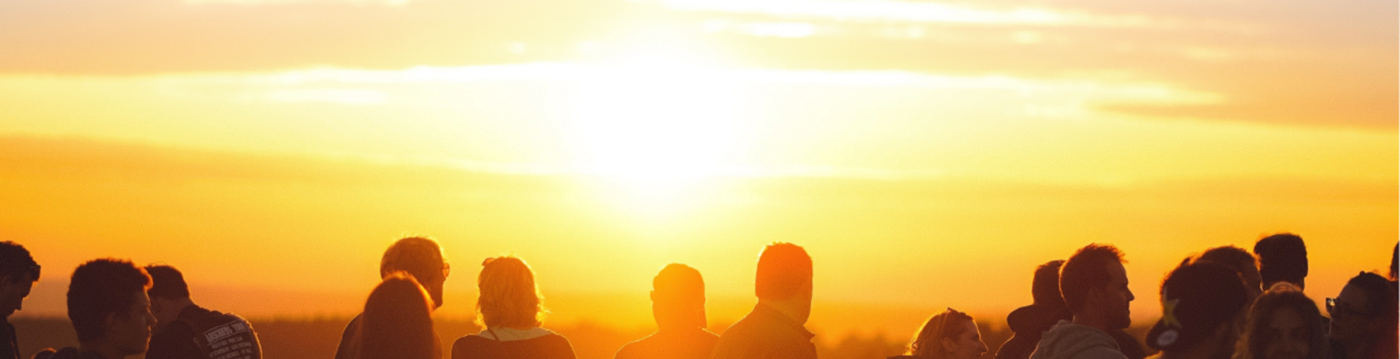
{"left": 146, "top": 306, "right": 262, "bottom": 359}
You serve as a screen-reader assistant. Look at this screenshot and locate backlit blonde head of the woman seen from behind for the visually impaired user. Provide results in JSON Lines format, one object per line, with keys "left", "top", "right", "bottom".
{"left": 476, "top": 255, "right": 545, "bottom": 328}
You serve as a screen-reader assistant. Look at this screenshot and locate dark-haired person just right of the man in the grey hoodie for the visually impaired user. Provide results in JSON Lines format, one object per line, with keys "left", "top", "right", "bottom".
{"left": 1147, "top": 261, "right": 1249, "bottom": 359}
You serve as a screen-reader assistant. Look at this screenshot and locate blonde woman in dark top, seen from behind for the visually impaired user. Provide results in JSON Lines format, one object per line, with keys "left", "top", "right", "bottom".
{"left": 452, "top": 257, "right": 574, "bottom": 359}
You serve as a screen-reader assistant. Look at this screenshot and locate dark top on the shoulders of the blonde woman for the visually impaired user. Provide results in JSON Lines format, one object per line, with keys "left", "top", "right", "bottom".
{"left": 452, "top": 334, "right": 575, "bottom": 359}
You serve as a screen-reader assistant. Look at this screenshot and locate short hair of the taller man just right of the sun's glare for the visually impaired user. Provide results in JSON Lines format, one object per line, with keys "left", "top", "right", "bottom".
{"left": 753, "top": 243, "right": 812, "bottom": 300}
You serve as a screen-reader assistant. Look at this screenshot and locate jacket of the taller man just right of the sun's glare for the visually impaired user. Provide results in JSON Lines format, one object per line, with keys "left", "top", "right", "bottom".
{"left": 710, "top": 303, "right": 816, "bottom": 359}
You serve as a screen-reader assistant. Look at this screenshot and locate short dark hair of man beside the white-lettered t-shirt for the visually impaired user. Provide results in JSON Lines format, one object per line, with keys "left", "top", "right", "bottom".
{"left": 69, "top": 258, "right": 151, "bottom": 342}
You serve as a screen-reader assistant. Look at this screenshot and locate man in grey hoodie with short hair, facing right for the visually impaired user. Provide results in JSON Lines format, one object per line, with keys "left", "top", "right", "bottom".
{"left": 1030, "top": 244, "right": 1134, "bottom": 359}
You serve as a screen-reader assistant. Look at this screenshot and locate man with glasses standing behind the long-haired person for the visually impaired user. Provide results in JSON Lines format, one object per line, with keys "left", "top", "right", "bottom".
{"left": 335, "top": 237, "right": 451, "bottom": 359}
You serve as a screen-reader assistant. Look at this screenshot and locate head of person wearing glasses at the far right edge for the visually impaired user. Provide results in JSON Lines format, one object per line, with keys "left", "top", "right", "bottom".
{"left": 1327, "top": 272, "right": 1396, "bottom": 346}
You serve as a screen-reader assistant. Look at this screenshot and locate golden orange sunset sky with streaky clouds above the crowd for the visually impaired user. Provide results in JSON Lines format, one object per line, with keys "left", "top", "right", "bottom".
{"left": 0, "top": 0, "right": 1400, "bottom": 332}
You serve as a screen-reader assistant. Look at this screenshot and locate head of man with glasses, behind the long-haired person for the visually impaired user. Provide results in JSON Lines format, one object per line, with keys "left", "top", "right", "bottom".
{"left": 379, "top": 237, "right": 452, "bottom": 309}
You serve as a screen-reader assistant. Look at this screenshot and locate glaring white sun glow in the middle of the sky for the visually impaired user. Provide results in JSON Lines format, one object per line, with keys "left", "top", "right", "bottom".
{"left": 570, "top": 49, "right": 743, "bottom": 206}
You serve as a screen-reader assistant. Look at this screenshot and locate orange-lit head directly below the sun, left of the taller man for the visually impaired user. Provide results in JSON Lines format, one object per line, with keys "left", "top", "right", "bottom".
{"left": 651, "top": 264, "right": 706, "bottom": 330}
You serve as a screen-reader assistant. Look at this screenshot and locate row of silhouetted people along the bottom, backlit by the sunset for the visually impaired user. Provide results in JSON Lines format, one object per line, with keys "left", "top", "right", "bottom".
{"left": 0, "top": 233, "right": 1400, "bottom": 359}
